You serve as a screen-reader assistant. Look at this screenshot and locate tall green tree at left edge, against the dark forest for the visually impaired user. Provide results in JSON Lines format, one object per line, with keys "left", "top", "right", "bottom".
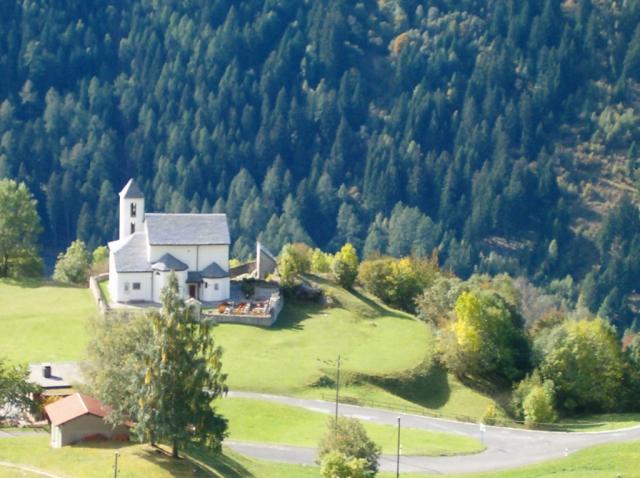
{"left": 0, "top": 179, "right": 42, "bottom": 277}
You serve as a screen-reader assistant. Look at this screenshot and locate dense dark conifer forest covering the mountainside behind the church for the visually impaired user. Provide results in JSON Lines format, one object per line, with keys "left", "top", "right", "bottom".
{"left": 0, "top": 0, "right": 640, "bottom": 320}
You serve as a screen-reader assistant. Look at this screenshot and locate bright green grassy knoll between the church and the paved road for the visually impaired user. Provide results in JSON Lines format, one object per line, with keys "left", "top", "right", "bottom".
{"left": 215, "top": 278, "right": 500, "bottom": 418}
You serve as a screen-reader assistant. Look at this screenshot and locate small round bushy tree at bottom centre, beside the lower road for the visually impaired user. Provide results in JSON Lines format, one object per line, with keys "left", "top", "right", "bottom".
{"left": 317, "top": 418, "right": 381, "bottom": 476}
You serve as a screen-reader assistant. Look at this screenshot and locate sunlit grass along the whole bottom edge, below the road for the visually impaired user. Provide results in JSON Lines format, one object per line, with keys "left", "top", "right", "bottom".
{"left": 0, "top": 436, "right": 640, "bottom": 478}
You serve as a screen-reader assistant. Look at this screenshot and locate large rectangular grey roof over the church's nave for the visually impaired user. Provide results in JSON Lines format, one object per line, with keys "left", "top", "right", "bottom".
{"left": 145, "top": 213, "right": 231, "bottom": 246}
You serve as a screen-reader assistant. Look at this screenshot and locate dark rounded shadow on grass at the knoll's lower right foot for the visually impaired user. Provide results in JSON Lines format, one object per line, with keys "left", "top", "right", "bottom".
{"left": 366, "top": 363, "right": 451, "bottom": 410}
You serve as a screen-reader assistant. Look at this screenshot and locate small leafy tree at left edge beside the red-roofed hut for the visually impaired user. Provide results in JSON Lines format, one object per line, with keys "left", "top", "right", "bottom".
{"left": 0, "top": 357, "right": 40, "bottom": 421}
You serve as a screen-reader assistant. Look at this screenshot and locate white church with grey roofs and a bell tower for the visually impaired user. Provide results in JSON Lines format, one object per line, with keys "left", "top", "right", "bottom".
{"left": 109, "top": 179, "right": 231, "bottom": 303}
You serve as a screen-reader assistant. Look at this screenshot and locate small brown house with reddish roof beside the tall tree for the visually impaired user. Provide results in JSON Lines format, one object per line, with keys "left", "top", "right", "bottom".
{"left": 45, "top": 393, "right": 129, "bottom": 448}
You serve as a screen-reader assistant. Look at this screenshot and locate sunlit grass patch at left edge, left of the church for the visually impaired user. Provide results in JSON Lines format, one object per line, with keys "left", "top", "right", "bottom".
{"left": 0, "top": 279, "right": 96, "bottom": 362}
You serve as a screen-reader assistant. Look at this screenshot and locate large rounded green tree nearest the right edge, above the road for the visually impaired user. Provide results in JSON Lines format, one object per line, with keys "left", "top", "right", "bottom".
{"left": 534, "top": 318, "right": 624, "bottom": 412}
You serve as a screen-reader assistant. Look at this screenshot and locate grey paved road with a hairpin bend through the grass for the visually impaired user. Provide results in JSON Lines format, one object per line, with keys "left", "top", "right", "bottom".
{"left": 225, "top": 392, "right": 640, "bottom": 474}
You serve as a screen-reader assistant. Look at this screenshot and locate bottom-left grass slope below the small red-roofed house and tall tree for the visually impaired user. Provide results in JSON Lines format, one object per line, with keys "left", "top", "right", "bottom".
{"left": 0, "top": 435, "right": 318, "bottom": 478}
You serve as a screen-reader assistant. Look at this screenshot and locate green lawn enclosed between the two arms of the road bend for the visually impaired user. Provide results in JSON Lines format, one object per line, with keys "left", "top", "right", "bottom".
{"left": 218, "top": 398, "right": 483, "bottom": 455}
